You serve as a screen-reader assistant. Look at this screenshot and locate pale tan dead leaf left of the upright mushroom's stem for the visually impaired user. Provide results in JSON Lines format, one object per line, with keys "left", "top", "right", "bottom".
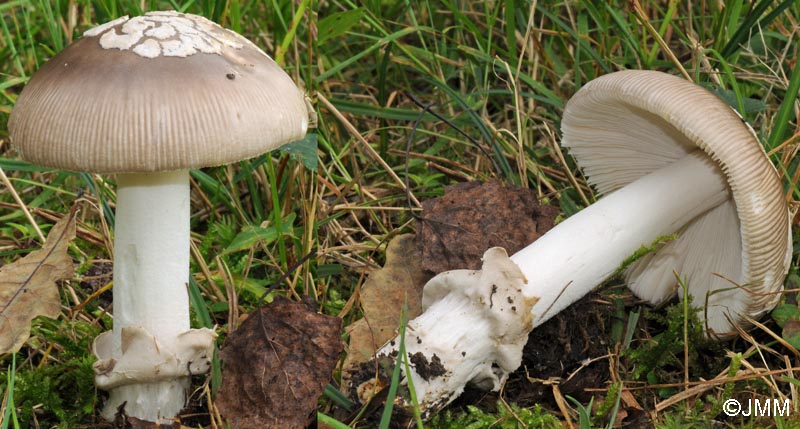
{"left": 0, "top": 208, "right": 76, "bottom": 355}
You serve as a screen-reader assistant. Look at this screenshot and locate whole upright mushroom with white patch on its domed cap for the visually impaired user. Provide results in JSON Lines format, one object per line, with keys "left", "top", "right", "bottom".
{"left": 9, "top": 12, "right": 309, "bottom": 423}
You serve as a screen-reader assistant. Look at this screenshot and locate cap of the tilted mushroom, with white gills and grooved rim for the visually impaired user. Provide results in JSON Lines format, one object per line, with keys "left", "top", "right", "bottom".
{"left": 562, "top": 70, "right": 791, "bottom": 335}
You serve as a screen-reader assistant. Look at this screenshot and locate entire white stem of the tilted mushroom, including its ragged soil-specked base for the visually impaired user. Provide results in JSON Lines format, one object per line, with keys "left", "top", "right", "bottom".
{"left": 377, "top": 150, "right": 729, "bottom": 415}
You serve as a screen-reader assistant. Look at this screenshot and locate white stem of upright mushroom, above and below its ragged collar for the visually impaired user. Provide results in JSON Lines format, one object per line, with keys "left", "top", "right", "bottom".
{"left": 104, "top": 170, "right": 190, "bottom": 422}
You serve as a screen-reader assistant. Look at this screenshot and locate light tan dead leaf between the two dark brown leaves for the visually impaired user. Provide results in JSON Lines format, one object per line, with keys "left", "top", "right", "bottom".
{"left": 342, "top": 234, "right": 430, "bottom": 389}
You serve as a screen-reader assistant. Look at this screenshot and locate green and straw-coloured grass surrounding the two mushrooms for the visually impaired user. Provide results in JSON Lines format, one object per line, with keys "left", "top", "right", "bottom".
{"left": 0, "top": 0, "right": 800, "bottom": 428}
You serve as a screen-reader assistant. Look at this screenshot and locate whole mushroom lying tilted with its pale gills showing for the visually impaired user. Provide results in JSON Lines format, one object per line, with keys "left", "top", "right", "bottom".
{"left": 370, "top": 71, "right": 791, "bottom": 414}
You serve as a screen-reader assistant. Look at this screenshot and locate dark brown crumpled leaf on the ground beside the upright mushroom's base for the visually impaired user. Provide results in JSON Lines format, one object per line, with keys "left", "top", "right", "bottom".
{"left": 216, "top": 297, "right": 342, "bottom": 429}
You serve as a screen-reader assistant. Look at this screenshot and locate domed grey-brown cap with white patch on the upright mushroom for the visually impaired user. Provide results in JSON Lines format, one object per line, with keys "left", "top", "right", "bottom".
{"left": 8, "top": 12, "right": 309, "bottom": 173}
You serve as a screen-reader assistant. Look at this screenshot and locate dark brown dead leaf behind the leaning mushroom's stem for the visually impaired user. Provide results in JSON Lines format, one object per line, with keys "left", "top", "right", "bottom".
{"left": 417, "top": 181, "right": 559, "bottom": 273}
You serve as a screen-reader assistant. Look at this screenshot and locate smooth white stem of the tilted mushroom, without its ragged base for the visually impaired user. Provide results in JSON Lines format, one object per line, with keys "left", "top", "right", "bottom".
{"left": 511, "top": 149, "right": 729, "bottom": 327}
